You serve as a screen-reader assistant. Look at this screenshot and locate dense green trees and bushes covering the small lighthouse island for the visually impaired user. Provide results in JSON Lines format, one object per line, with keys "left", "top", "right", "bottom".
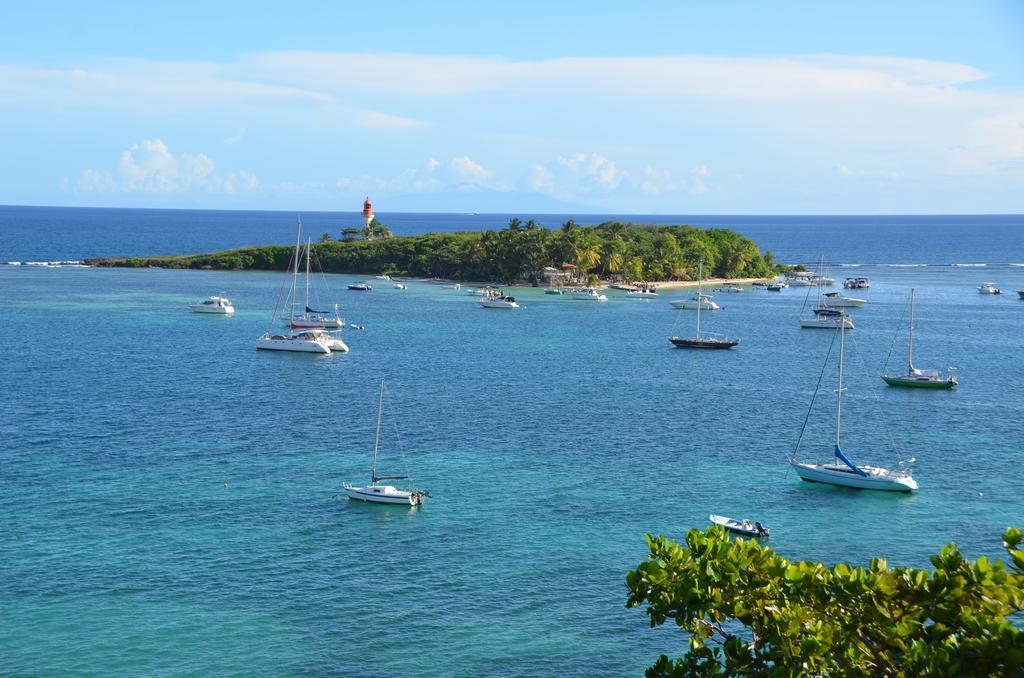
{"left": 90, "top": 219, "right": 777, "bottom": 283}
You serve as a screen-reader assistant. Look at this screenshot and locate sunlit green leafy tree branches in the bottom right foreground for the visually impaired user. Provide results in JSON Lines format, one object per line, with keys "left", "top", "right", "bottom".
{"left": 626, "top": 527, "right": 1024, "bottom": 676}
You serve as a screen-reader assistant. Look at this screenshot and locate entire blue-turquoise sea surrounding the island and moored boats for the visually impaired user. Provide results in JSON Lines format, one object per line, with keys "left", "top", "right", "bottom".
{"left": 0, "top": 208, "right": 1024, "bottom": 676}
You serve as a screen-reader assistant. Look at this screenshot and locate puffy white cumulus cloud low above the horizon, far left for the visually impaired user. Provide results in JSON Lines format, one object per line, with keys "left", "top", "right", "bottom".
{"left": 76, "top": 138, "right": 259, "bottom": 194}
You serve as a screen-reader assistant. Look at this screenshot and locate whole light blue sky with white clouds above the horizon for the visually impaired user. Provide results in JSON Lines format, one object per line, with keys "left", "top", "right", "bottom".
{"left": 0, "top": 0, "right": 1024, "bottom": 214}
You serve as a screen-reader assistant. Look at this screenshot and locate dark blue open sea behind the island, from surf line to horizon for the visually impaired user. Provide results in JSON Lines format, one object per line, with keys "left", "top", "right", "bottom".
{"left": 0, "top": 206, "right": 1024, "bottom": 265}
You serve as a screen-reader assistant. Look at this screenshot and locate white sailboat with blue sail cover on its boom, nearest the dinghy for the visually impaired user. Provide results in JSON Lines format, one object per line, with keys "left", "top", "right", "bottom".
{"left": 790, "top": 325, "right": 918, "bottom": 492}
